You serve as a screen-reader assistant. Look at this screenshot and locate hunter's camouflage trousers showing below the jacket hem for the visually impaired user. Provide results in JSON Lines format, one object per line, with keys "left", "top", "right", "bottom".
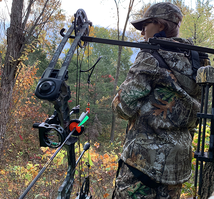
{"left": 112, "top": 164, "right": 182, "bottom": 199}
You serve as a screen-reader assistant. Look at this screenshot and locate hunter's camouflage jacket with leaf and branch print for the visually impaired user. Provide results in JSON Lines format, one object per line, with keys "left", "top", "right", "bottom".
{"left": 112, "top": 38, "right": 201, "bottom": 185}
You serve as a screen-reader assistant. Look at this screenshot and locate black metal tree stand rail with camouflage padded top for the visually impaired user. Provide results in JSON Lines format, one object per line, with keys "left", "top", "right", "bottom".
{"left": 193, "top": 66, "right": 214, "bottom": 199}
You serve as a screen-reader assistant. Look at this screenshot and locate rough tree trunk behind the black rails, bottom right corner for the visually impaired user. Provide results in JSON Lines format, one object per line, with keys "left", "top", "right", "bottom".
{"left": 201, "top": 162, "right": 214, "bottom": 199}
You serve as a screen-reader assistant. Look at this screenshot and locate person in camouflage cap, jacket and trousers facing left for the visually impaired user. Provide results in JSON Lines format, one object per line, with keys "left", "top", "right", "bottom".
{"left": 112, "top": 3, "right": 204, "bottom": 199}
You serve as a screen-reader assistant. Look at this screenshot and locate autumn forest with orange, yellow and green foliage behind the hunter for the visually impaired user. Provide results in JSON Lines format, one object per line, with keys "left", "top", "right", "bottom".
{"left": 0, "top": 0, "right": 214, "bottom": 199}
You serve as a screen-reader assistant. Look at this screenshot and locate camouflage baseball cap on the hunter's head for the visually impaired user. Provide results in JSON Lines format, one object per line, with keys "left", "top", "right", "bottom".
{"left": 131, "top": 2, "right": 183, "bottom": 30}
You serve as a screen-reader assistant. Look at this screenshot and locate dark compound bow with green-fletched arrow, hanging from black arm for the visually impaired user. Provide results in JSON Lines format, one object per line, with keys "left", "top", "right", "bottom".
{"left": 20, "top": 9, "right": 92, "bottom": 199}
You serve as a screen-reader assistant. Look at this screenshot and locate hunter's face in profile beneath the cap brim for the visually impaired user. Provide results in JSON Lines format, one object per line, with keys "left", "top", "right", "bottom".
{"left": 141, "top": 20, "right": 164, "bottom": 41}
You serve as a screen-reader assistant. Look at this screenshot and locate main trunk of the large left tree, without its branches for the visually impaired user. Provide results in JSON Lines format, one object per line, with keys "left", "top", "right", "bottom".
{"left": 0, "top": 0, "right": 24, "bottom": 158}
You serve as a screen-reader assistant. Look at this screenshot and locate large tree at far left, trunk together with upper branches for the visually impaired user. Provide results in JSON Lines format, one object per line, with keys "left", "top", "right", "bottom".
{"left": 0, "top": 0, "right": 60, "bottom": 159}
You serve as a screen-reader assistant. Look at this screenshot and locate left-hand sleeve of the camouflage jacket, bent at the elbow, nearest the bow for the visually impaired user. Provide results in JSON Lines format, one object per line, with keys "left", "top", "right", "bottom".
{"left": 112, "top": 51, "right": 158, "bottom": 120}
